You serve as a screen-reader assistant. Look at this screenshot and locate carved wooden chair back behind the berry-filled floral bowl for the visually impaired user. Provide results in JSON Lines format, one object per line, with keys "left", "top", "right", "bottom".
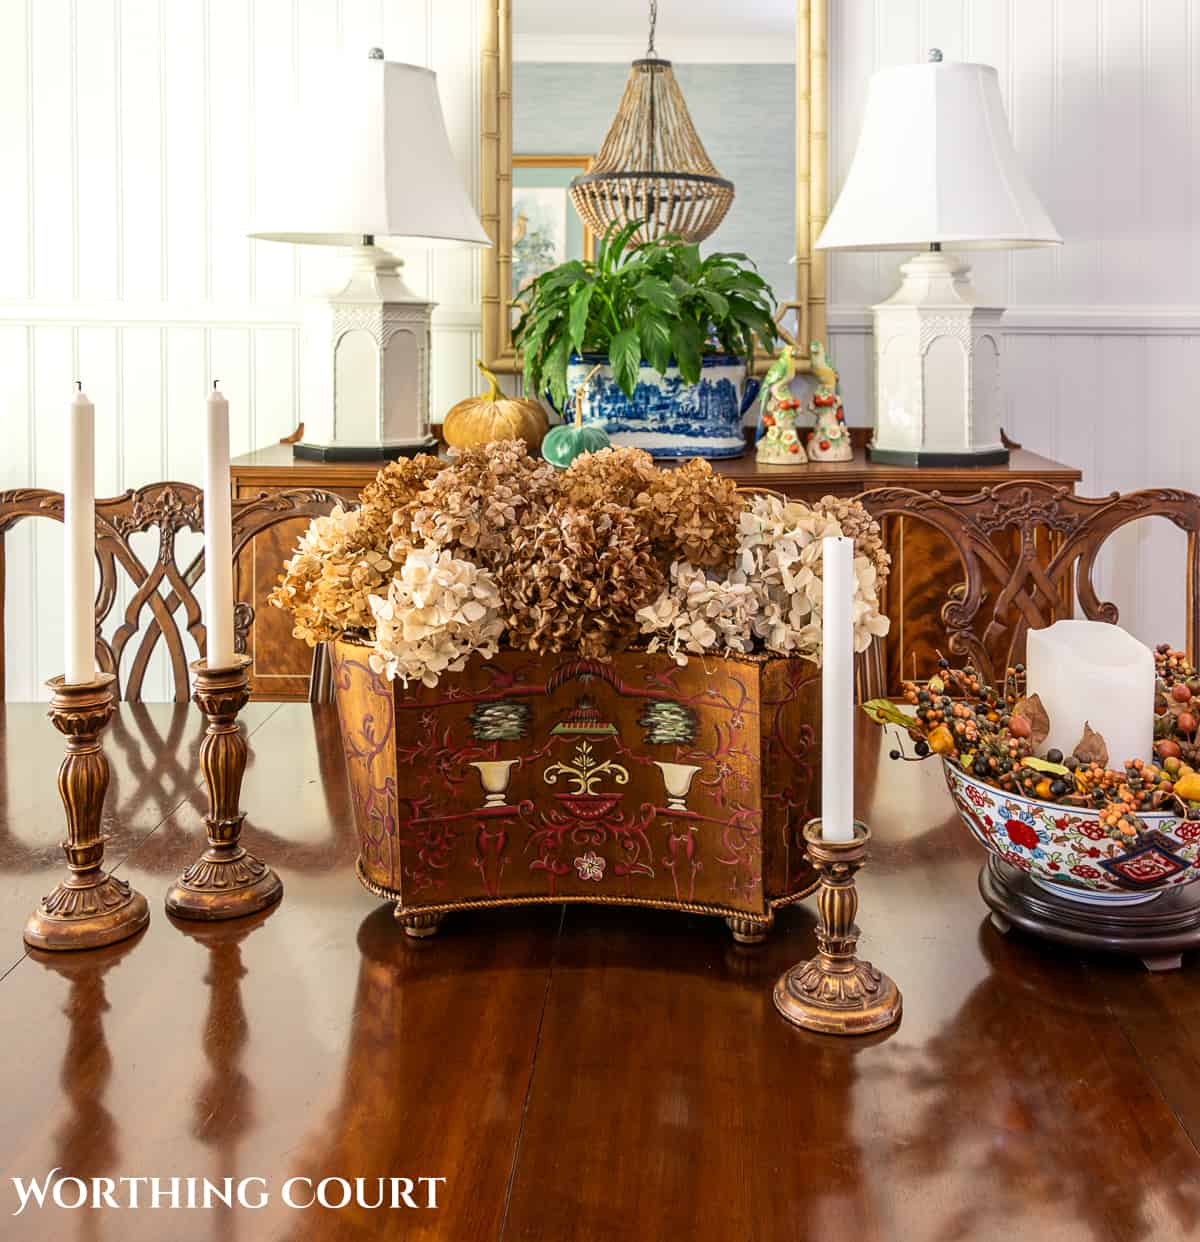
{"left": 858, "top": 479, "right": 1200, "bottom": 679}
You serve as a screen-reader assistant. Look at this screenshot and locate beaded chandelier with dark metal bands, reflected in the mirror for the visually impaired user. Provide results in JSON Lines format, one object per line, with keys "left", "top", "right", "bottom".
{"left": 570, "top": 0, "right": 733, "bottom": 241}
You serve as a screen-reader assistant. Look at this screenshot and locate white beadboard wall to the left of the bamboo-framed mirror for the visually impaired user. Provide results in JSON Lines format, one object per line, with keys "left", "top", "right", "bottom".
{"left": 0, "top": 0, "right": 482, "bottom": 699}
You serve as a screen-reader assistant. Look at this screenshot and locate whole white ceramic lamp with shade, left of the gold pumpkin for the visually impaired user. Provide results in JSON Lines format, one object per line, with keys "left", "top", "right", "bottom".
{"left": 250, "top": 47, "right": 491, "bottom": 461}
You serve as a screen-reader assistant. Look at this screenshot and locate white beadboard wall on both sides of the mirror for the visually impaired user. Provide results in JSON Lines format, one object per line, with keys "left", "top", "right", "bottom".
{"left": 0, "top": 0, "right": 1200, "bottom": 699}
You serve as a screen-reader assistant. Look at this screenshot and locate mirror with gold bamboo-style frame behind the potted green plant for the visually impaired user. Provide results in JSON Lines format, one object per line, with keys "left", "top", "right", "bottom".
{"left": 481, "top": 0, "right": 827, "bottom": 373}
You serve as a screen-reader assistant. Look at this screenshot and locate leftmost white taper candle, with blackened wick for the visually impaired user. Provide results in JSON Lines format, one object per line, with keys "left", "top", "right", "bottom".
{"left": 62, "top": 384, "right": 96, "bottom": 686}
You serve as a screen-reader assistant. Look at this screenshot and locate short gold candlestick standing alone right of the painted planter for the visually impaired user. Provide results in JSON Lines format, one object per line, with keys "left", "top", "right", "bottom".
{"left": 775, "top": 820, "right": 902, "bottom": 1035}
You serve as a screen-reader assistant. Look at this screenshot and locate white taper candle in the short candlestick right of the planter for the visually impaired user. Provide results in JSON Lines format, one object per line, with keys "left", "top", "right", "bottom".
{"left": 821, "top": 537, "right": 855, "bottom": 841}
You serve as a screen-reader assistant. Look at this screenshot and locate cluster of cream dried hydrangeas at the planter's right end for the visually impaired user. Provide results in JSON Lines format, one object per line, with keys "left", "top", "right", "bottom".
{"left": 637, "top": 496, "right": 889, "bottom": 663}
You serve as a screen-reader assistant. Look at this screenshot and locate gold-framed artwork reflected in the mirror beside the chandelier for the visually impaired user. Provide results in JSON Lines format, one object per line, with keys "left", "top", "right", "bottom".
{"left": 512, "top": 155, "right": 595, "bottom": 298}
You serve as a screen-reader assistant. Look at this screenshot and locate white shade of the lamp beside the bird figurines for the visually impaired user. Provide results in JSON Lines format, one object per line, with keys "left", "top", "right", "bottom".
{"left": 816, "top": 62, "right": 1062, "bottom": 250}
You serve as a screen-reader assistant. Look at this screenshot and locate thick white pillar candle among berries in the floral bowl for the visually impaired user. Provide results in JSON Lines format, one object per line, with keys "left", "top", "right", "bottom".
{"left": 1025, "top": 621, "right": 1154, "bottom": 771}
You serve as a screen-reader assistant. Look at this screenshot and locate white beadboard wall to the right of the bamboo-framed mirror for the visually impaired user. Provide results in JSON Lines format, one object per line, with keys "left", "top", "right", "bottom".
{"left": 829, "top": 0, "right": 1200, "bottom": 660}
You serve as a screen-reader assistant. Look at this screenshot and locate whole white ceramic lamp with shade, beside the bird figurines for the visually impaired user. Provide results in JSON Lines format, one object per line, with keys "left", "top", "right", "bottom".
{"left": 816, "top": 50, "right": 1062, "bottom": 466}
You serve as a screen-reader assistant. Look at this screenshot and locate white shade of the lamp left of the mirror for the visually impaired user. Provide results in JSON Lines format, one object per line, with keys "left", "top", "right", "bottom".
{"left": 250, "top": 53, "right": 491, "bottom": 246}
